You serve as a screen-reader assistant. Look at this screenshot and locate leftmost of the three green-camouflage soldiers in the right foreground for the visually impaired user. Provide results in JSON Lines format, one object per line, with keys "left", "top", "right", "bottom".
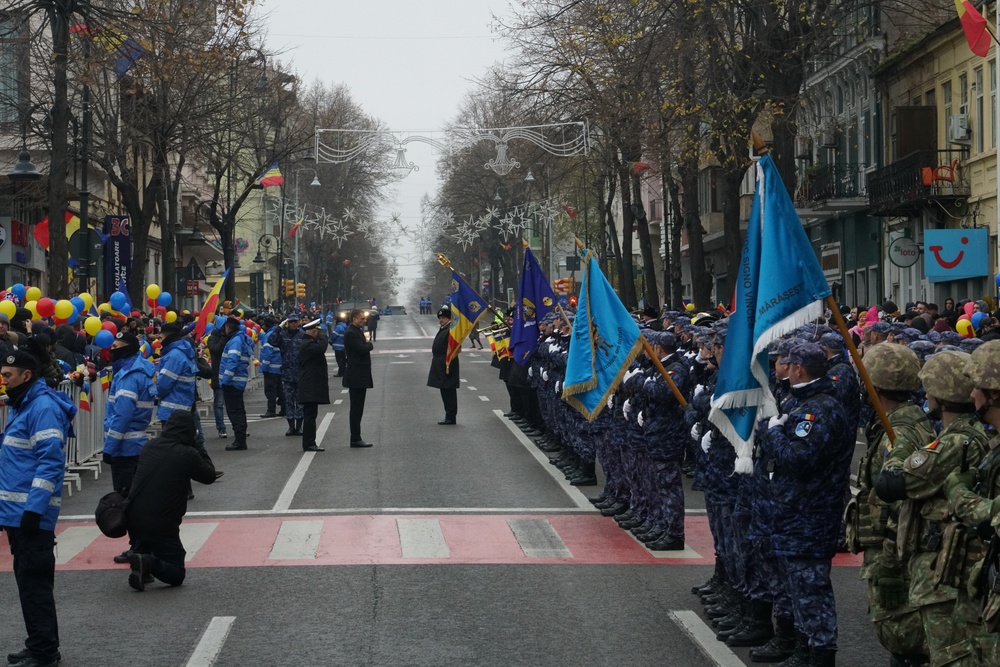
{"left": 847, "top": 343, "right": 934, "bottom": 667}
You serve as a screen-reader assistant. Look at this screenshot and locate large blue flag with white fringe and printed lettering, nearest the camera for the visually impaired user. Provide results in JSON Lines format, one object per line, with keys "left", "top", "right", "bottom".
{"left": 708, "top": 155, "right": 830, "bottom": 473}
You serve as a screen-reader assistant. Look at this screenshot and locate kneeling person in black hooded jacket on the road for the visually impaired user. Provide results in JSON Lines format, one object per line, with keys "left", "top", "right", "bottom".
{"left": 126, "top": 410, "right": 219, "bottom": 591}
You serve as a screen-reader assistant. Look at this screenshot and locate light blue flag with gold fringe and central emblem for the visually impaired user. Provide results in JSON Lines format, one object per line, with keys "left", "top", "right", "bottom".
{"left": 563, "top": 248, "right": 642, "bottom": 421}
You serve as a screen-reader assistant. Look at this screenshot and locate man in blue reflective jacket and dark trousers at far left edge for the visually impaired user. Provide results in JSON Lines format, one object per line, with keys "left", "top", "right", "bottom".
{"left": 0, "top": 346, "right": 76, "bottom": 667}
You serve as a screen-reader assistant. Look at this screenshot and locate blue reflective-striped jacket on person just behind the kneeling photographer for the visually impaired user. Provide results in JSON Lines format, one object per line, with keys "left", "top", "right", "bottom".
{"left": 104, "top": 354, "right": 156, "bottom": 456}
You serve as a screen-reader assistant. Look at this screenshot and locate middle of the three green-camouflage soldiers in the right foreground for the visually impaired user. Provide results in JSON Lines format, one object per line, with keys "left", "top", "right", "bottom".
{"left": 875, "top": 352, "right": 986, "bottom": 667}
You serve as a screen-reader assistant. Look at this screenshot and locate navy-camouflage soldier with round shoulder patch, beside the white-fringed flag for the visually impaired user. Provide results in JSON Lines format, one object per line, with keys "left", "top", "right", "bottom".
{"left": 767, "top": 343, "right": 854, "bottom": 667}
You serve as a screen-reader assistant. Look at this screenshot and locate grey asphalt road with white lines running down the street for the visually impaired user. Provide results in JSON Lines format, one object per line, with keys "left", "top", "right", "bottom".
{"left": 0, "top": 315, "right": 885, "bottom": 667}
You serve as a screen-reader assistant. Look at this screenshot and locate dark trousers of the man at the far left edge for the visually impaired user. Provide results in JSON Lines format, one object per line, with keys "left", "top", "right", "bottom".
{"left": 4, "top": 526, "right": 59, "bottom": 662}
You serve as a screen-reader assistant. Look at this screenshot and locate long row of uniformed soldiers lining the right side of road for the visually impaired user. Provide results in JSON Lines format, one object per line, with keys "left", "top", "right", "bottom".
{"left": 501, "top": 313, "right": 1000, "bottom": 667}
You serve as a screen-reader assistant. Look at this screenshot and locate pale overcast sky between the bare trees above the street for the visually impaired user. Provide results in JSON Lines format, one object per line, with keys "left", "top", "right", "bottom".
{"left": 261, "top": 0, "right": 509, "bottom": 296}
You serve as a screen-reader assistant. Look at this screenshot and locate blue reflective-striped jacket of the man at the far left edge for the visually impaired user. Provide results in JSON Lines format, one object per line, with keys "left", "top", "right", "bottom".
{"left": 0, "top": 379, "right": 76, "bottom": 530}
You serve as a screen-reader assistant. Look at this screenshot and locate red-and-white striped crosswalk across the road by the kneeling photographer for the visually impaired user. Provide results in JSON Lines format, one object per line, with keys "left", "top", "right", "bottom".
{"left": 0, "top": 514, "right": 859, "bottom": 571}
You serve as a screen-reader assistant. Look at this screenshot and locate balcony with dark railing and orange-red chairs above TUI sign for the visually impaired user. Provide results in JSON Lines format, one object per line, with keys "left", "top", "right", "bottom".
{"left": 868, "top": 150, "right": 969, "bottom": 216}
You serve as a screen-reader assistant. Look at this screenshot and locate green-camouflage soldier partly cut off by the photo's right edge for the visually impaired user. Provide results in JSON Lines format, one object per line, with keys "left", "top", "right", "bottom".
{"left": 944, "top": 340, "right": 1000, "bottom": 665}
